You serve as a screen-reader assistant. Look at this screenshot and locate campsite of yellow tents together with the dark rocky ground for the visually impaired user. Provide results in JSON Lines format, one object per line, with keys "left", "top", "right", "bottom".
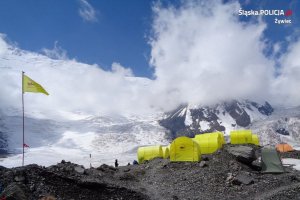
{"left": 0, "top": 130, "right": 300, "bottom": 200}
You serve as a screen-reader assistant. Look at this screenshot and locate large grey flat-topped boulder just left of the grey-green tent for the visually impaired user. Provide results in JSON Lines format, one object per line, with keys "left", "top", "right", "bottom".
{"left": 227, "top": 145, "right": 257, "bottom": 165}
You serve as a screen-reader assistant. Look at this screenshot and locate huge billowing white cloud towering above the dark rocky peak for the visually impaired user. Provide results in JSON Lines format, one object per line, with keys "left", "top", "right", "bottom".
{"left": 151, "top": 1, "right": 274, "bottom": 109}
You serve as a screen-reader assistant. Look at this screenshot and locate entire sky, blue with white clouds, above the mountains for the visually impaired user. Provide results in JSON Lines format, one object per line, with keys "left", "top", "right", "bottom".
{"left": 0, "top": 0, "right": 300, "bottom": 116}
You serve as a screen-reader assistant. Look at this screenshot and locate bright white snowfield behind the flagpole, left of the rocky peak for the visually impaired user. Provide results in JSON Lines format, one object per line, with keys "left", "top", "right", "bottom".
{"left": 0, "top": 111, "right": 168, "bottom": 167}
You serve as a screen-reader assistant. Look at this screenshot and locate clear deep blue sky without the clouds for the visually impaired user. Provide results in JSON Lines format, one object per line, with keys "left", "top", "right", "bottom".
{"left": 0, "top": 0, "right": 300, "bottom": 77}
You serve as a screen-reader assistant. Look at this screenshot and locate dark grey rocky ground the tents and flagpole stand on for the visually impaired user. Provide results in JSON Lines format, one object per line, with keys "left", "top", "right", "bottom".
{"left": 0, "top": 145, "right": 300, "bottom": 200}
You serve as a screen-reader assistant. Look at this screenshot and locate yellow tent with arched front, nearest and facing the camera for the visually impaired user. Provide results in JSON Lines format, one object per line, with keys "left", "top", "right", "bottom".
{"left": 170, "top": 136, "right": 201, "bottom": 162}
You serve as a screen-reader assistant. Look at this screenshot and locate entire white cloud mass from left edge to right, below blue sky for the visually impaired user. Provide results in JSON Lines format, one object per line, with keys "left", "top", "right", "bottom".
{"left": 0, "top": 0, "right": 300, "bottom": 119}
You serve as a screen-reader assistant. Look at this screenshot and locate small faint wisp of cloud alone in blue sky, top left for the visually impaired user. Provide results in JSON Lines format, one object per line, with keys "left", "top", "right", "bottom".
{"left": 79, "top": 0, "right": 98, "bottom": 22}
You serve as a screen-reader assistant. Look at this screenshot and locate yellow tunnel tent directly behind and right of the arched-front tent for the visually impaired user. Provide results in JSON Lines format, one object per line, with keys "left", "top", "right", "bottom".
{"left": 193, "top": 133, "right": 223, "bottom": 154}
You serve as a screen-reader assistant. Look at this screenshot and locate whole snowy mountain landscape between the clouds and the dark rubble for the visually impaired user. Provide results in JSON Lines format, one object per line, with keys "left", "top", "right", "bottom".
{"left": 0, "top": 100, "right": 300, "bottom": 167}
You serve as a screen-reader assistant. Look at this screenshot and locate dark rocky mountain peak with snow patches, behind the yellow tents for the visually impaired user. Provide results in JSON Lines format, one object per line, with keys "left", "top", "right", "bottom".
{"left": 160, "top": 100, "right": 274, "bottom": 138}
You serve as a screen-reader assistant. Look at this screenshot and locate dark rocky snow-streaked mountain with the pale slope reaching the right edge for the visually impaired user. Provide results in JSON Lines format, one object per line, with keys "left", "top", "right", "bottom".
{"left": 160, "top": 100, "right": 300, "bottom": 145}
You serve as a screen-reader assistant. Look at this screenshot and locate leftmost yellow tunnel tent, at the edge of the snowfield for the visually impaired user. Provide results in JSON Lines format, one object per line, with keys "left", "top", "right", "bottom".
{"left": 138, "top": 145, "right": 163, "bottom": 163}
